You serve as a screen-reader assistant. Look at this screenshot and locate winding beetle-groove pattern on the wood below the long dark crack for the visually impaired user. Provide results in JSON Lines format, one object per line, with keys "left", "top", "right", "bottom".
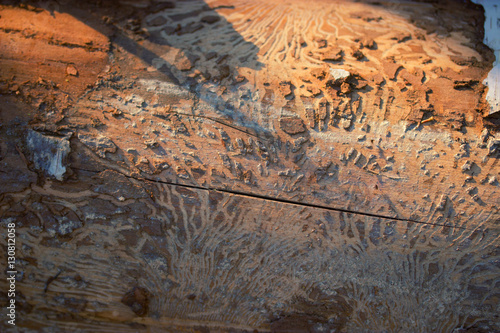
{"left": 2, "top": 171, "right": 499, "bottom": 332}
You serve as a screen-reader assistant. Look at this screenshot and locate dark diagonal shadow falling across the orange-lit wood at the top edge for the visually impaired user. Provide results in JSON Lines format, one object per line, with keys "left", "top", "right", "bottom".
{"left": 51, "top": 0, "right": 267, "bottom": 136}
